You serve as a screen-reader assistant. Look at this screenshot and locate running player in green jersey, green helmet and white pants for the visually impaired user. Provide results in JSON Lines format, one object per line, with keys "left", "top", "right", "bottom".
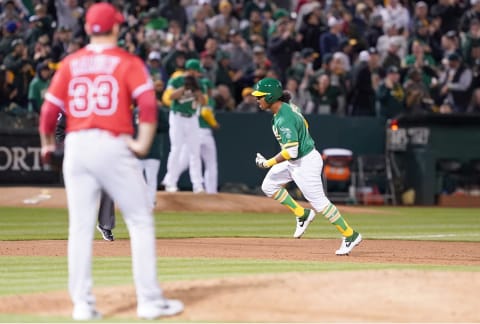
{"left": 252, "top": 78, "right": 362, "bottom": 255}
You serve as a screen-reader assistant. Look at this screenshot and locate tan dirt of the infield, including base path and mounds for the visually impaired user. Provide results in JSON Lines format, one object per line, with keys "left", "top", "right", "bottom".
{"left": 0, "top": 188, "right": 480, "bottom": 322}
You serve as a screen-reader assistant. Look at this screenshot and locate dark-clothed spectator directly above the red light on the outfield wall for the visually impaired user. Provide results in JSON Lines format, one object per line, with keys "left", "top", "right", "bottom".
{"left": 376, "top": 65, "right": 405, "bottom": 118}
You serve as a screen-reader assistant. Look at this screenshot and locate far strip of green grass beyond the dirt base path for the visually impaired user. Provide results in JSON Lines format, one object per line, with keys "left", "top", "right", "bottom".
{"left": 0, "top": 207, "right": 480, "bottom": 242}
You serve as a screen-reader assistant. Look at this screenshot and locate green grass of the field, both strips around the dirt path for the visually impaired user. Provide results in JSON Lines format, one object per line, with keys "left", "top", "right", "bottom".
{"left": 0, "top": 207, "right": 480, "bottom": 322}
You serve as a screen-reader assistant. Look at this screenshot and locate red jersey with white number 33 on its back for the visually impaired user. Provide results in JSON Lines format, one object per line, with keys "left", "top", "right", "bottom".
{"left": 45, "top": 45, "right": 153, "bottom": 134}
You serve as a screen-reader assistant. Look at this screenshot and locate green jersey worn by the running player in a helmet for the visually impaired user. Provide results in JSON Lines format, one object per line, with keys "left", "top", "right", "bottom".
{"left": 272, "top": 103, "right": 315, "bottom": 160}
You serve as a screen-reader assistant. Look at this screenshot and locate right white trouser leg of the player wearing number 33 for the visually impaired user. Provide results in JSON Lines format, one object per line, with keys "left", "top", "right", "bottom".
{"left": 97, "top": 132, "right": 167, "bottom": 308}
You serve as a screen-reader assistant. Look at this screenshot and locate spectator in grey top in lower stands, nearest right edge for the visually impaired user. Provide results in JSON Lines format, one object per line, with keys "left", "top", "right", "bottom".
{"left": 439, "top": 52, "right": 473, "bottom": 113}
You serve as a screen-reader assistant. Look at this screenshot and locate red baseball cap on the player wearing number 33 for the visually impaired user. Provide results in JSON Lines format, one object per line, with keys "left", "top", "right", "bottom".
{"left": 85, "top": 2, "right": 125, "bottom": 34}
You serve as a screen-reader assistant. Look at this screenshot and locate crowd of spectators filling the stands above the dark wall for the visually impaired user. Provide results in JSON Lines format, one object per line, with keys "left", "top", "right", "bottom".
{"left": 0, "top": 0, "right": 480, "bottom": 124}
